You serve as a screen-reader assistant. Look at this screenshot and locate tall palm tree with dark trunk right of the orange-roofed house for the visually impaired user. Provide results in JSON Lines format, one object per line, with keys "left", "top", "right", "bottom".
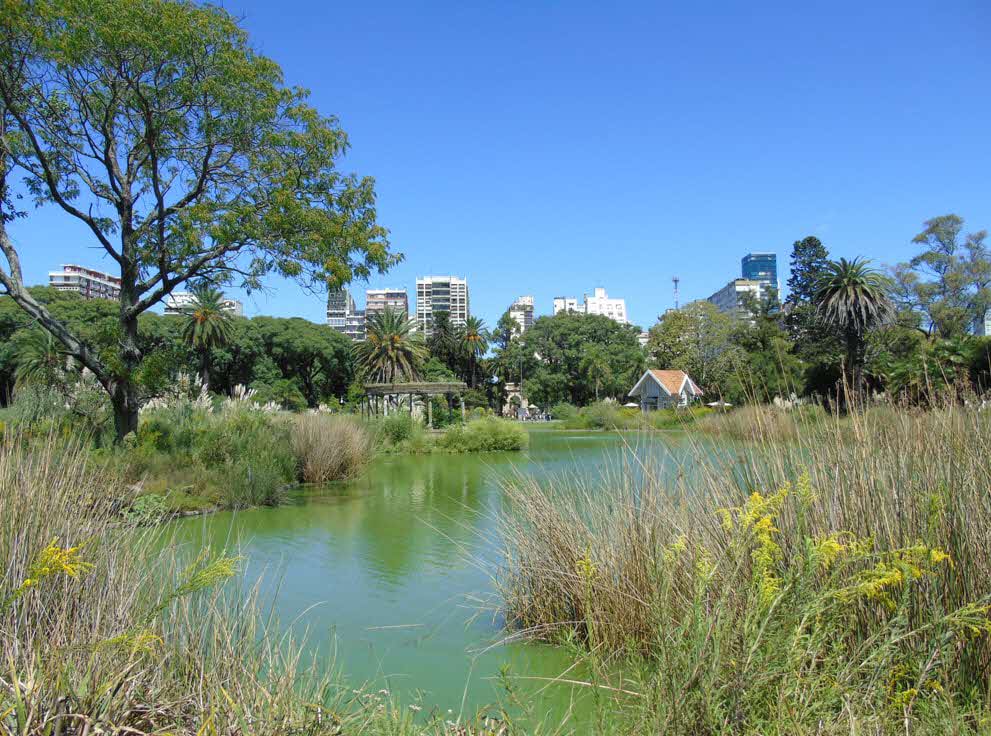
{"left": 813, "top": 258, "right": 894, "bottom": 392}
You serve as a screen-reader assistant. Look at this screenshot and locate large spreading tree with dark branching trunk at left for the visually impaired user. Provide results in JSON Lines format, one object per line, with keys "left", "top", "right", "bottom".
{"left": 0, "top": 0, "right": 399, "bottom": 438}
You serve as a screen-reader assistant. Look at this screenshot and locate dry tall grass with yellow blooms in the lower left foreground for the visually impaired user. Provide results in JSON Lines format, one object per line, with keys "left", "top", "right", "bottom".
{"left": 0, "top": 434, "right": 528, "bottom": 736}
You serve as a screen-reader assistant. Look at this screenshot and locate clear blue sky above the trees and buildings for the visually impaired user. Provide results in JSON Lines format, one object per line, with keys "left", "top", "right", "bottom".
{"left": 13, "top": 0, "right": 991, "bottom": 326}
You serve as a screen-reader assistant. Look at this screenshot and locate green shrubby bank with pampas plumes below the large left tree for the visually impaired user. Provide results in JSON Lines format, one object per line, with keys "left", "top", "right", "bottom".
{"left": 0, "top": 377, "right": 528, "bottom": 523}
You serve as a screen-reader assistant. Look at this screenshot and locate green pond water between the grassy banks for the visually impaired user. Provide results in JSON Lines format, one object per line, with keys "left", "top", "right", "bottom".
{"left": 172, "top": 429, "right": 744, "bottom": 715}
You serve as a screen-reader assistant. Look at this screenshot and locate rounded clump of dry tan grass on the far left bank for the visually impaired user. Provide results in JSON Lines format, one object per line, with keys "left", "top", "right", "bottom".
{"left": 291, "top": 414, "right": 372, "bottom": 483}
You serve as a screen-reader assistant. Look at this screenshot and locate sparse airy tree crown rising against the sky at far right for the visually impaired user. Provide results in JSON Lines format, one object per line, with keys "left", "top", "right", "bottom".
{"left": 892, "top": 215, "right": 991, "bottom": 339}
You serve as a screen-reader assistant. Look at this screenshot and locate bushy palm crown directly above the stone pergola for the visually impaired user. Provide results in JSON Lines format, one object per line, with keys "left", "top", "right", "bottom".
{"left": 355, "top": 309, "right": 427, "bottom": 383}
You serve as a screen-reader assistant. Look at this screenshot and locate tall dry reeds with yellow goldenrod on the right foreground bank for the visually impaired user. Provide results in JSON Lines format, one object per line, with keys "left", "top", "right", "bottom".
{"left": 500, "top": 408, "right": 991, "bottom": 734}
